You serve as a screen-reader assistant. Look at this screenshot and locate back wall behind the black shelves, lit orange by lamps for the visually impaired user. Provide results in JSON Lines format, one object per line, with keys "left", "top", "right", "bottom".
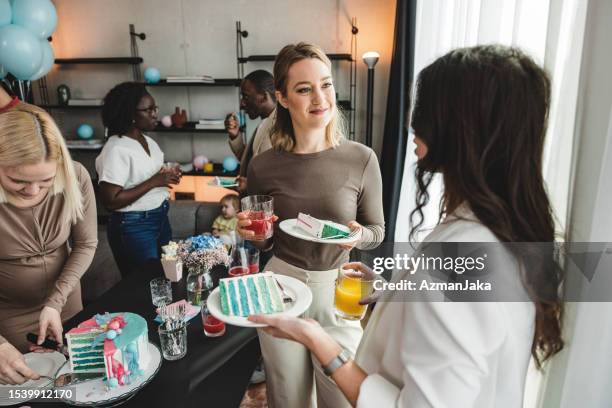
{"left": 43, "top": 0, "right": 395, "bottom": 161}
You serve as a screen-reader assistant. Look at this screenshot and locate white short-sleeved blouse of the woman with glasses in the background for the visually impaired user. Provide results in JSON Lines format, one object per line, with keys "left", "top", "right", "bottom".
{"left": 96, "top": 135, "right": 170, "bottom": 211}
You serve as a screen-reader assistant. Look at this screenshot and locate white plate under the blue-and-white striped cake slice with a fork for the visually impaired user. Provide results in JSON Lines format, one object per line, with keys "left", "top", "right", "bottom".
{"left": 207, "top": 273, "right": 312, "bottom": 327}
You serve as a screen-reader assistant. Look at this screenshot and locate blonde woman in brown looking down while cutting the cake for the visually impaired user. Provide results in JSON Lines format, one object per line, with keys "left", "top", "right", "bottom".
{"left": 0, "top": 104, "right": 97, "bottom": 384}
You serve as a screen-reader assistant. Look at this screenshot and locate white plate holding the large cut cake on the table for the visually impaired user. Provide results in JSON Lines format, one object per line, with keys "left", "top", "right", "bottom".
{"left": 56, "top": 343, "right": 162, "bottom": 407}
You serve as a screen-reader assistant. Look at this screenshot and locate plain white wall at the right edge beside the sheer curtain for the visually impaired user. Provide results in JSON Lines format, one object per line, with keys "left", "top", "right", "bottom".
{"left": 542, "top": 0, "right": 612, "bottom": 408}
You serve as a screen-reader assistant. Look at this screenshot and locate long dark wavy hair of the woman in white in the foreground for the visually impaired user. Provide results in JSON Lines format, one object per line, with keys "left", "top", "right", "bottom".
{"left": 410, "top": 45, "right": 564, "bottom": 366}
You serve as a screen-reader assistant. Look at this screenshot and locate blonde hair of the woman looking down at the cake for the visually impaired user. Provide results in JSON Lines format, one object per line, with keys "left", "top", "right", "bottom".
{"left": 0, "top": 104, "right": 83, "bottom": 224}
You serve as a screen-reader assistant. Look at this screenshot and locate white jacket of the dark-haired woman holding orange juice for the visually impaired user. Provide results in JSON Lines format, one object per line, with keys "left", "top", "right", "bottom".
{"left": 355, "top": 209, "right": 535, "bottom": 408}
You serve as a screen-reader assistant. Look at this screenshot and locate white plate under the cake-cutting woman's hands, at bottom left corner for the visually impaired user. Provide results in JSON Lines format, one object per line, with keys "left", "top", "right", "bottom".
{"left": 0, "top": 351, "right": 66, "bottom": 406}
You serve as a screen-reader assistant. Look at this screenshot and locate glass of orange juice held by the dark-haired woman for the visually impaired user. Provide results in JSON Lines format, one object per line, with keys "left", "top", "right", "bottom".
{"left": 334, "top": 268, "right": 374, "bottom": 320}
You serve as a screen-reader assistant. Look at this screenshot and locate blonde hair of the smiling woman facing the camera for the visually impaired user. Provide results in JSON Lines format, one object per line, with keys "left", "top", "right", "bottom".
{"left": 270, "top": 42, "right": 345, "bottom": 152}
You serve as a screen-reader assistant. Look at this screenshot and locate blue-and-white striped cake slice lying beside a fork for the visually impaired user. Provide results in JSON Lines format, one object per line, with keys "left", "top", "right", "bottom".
{"left": 219, "top": 272, "right": 285, "bottom": 317}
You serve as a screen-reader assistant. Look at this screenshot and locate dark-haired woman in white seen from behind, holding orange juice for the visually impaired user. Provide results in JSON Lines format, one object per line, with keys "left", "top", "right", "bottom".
{"left": 251, "top": 46, "right": 563, "bottom": 407}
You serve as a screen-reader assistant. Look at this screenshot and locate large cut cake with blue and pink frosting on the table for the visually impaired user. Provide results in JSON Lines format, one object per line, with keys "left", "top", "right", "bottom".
{"left": 66, "top": 312, "right": 149, "bottom": 388}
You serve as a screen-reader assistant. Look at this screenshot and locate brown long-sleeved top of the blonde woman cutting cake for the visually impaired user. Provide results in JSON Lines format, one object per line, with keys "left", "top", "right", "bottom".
{"left": 0, "top": 163, "right": 98, "bottom": 352}
